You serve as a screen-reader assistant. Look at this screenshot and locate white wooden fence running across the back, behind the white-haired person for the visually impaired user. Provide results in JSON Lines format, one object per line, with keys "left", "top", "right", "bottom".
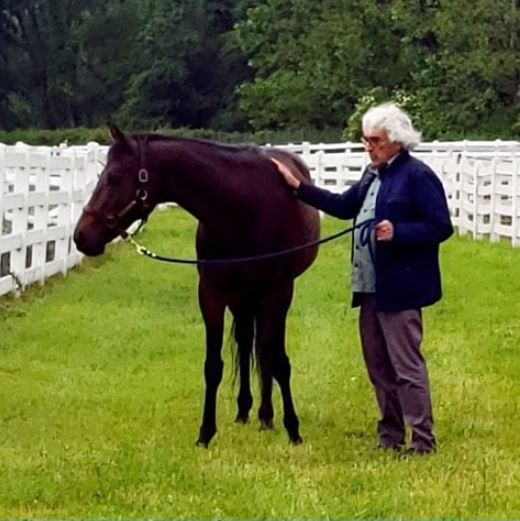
{"left": 286, "top": 140, "right": 520, "bottom": 247}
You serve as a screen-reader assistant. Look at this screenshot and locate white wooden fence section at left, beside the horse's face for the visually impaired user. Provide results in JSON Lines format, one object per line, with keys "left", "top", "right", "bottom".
{"left": 0, "top": 143, "right": 106, "bottom": 295}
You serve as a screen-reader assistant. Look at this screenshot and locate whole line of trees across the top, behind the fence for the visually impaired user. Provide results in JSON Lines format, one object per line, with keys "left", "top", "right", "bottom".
{"left": 0, "top": 0, "right": 520, "bottom": 139}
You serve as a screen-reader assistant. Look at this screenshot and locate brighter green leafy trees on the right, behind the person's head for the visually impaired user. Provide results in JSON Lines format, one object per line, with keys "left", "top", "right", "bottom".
{"left": 237, "top": 0, "right": 520, "bottom": 138}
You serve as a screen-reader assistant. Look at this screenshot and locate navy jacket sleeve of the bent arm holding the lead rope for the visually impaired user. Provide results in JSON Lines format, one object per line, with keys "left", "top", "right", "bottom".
{"left": 392, "top": 169, "right": 453, "bottom": 246}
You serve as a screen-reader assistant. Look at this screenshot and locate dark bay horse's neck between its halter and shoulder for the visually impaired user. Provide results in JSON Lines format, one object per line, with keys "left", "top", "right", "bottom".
{"left": 155, "top": 142, "right": 246, "bottom": 222}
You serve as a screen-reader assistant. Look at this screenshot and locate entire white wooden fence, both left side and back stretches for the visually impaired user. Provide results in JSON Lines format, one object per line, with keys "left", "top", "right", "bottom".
{"left": 0, "top": 141, "right": 520, "bottom": 295}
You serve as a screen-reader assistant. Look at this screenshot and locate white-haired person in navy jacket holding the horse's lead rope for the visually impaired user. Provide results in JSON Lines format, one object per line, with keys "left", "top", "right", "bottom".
{"left": 275, "top": 104, "right": 453, "bottom": 455}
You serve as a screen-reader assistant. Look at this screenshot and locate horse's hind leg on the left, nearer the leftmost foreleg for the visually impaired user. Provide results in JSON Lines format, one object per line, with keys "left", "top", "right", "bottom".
{"left": 232, "top": 309, "right": 255, "bottom": 423}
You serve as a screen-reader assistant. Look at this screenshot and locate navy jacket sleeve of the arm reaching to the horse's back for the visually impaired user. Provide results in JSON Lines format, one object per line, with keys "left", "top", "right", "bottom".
{"left": 295, "top": 181, "right": 362, "bottom": 219}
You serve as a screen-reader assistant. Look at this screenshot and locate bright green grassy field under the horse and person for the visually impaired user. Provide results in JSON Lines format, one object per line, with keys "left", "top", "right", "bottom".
{"left": 0, "top": 210, "right": 520, "bottom": 520}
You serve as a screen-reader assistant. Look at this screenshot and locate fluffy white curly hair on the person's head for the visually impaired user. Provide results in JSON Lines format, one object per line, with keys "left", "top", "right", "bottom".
{"left": 362, "top": 103, "right": 421, "bottom": 150}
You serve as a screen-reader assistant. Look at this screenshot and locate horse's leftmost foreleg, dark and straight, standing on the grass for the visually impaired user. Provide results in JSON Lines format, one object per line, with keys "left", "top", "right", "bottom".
{"left": 197, "top": 283, "right": 225, "bottom": 447}
